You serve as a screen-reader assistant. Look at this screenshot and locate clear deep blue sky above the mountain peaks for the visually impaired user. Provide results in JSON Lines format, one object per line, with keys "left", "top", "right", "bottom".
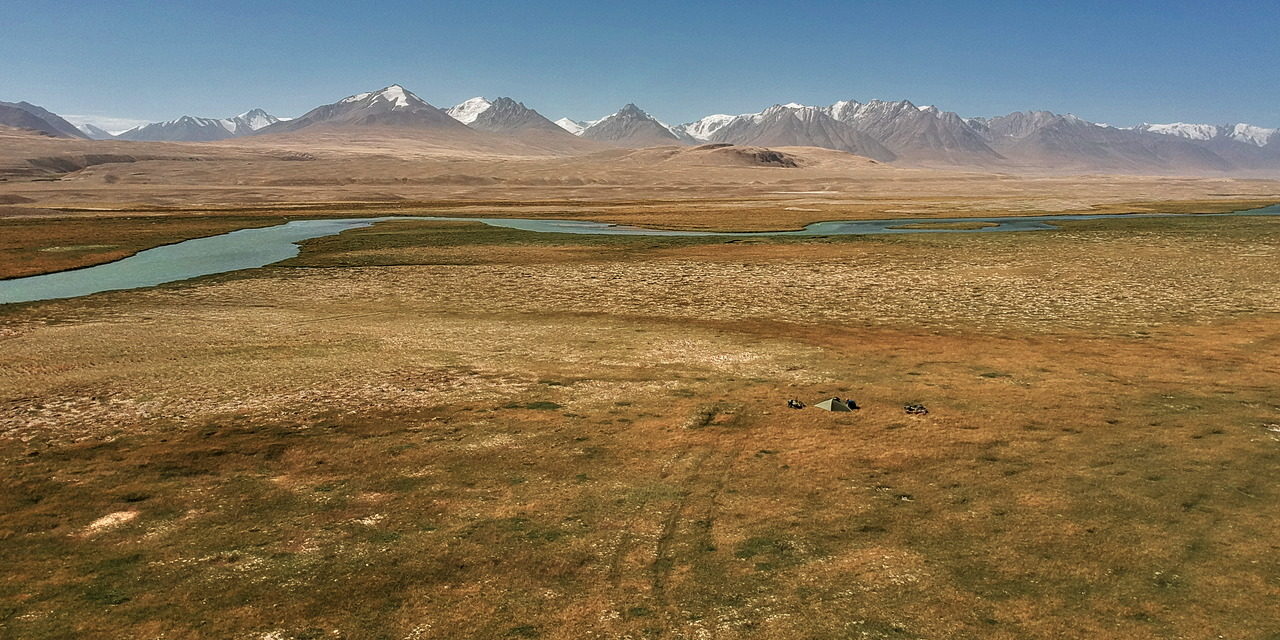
{"left": 0, "top": 0, "right": 1280, "bottom": 127}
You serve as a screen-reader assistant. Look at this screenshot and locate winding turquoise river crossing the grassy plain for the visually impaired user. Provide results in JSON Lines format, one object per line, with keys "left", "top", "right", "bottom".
{"left": 0, "top": 205, "right": 1280, "bottom": 303}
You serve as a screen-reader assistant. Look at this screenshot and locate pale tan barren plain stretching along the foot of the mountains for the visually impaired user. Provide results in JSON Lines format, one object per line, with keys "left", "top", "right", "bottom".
{"left": 0, "top": 126, "right": 1280, "bottom": 229}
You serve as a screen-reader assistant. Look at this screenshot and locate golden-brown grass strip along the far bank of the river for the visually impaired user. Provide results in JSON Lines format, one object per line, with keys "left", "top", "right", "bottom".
{"left": 0, "top": 192, "right": 1280, "bottom": 278}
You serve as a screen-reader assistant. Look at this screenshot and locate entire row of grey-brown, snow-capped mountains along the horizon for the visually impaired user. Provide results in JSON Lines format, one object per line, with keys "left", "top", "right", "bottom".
{"left": 0, "top": 84, "right": 1280, "bottom": 173}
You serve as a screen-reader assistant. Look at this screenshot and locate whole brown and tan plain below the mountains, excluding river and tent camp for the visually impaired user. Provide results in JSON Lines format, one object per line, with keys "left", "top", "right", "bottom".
{"left": 0, "top": 126, "right": 1280, "bottom": 640}
